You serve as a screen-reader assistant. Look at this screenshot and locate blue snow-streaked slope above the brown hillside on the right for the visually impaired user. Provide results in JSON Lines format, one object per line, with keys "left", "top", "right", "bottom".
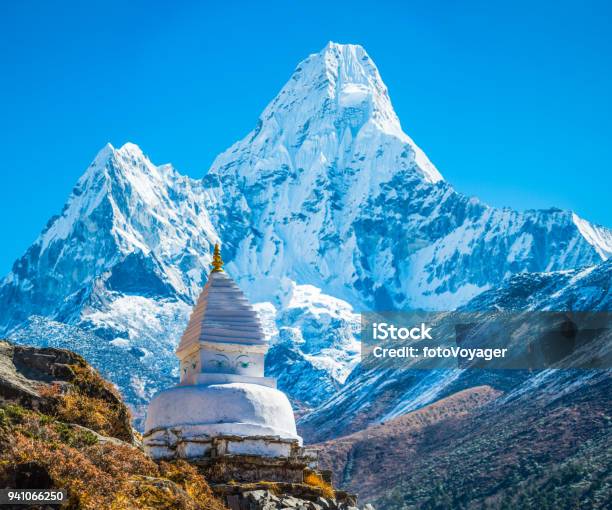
{"left": 298, "top": 260, "right": 612, "bottom": 442}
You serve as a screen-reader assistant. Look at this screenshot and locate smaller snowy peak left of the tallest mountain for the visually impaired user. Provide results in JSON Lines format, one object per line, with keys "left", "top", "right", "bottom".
{"left": 0, "top": 143, "right": 219, "bottom": 331}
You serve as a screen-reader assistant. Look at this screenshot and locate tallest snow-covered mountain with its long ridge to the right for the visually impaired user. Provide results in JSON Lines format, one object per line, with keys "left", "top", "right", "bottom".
{"left": 204, "top": 43, "right": 610, "bottom": 309}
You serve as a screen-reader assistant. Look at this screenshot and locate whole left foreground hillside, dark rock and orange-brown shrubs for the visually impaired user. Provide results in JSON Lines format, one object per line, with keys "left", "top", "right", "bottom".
{"left": 0, "top": 341, "right": 224, "bottom": 510}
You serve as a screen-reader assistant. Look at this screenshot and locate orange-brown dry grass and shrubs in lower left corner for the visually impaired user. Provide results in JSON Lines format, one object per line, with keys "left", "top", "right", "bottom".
{"left": 0, "top": 405, "right": 224, "bottom": 510}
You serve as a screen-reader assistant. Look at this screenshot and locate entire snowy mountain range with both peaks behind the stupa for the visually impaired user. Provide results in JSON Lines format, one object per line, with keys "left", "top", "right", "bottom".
{"left": 0, "top": 43, "right": 612, "bottom": 426}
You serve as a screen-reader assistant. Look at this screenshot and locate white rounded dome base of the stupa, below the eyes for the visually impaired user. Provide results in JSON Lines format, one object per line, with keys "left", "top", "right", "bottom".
{"left": 143, "top": 380, "right": 302, "bottom": 459}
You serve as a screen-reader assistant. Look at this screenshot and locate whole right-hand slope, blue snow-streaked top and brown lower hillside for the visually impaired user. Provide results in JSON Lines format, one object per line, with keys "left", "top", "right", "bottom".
{"left": 316, "top": 260, "right": 612, "bottom": 509}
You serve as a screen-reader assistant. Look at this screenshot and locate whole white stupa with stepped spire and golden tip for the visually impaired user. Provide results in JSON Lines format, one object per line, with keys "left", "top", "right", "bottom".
{"left": 144, "top": 246, "right": 303, "bottom": 460}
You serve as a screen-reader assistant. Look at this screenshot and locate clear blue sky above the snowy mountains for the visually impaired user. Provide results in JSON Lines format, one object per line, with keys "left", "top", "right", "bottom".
{"left": 0, "top": 0, "right": 612, "bottom": 274}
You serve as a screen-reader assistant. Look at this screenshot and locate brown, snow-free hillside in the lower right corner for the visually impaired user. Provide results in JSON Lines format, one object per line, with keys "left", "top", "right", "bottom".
{"left": 319, "top": 371, "right": 612, "bottom": 510}
